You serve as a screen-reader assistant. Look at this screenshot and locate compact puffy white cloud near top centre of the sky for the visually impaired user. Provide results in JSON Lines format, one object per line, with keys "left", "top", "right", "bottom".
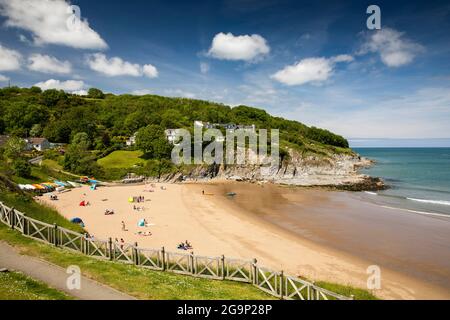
{"left": 208, "top": 32, "right": 270, "bottom": 61}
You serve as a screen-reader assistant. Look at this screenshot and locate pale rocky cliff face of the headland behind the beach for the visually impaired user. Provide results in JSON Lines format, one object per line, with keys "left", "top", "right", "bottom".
{"left": 154, "top": 150, "right": 385, "bottom": 191}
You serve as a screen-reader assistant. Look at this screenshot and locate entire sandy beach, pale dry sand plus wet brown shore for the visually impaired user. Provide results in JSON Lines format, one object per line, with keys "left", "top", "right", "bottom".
{"left": 38, "top": 183, "right": 450, "bottom": 299}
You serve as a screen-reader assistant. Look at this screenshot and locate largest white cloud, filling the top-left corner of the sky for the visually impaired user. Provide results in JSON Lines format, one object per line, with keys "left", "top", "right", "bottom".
{"left": 0, "top": 0, "right": 107, "bottom": 49}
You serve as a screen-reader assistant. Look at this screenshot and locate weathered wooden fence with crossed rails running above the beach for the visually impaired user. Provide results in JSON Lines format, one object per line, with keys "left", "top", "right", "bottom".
{"left": 0, "top": 202, "right": 353, "bottom": 300}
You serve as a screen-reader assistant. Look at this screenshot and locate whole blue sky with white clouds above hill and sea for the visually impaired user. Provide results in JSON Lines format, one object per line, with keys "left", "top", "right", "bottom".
{"left": 0, "top": 0, "right": 450, "bottom": 146}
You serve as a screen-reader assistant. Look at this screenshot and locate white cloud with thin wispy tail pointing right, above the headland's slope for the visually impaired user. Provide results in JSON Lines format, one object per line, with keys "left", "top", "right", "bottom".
{"left": 271, "top": 55, "right": 353, "bottom": 86}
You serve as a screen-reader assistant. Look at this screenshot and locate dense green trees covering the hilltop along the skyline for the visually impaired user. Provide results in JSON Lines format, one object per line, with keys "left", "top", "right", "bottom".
{"left": 0, "top": 87, "right": 348, "bottom": 151}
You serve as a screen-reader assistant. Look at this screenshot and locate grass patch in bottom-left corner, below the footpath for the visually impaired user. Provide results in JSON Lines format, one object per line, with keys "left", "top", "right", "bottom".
{"left": 0, "top": 272, "right": 72, "bottom": 300}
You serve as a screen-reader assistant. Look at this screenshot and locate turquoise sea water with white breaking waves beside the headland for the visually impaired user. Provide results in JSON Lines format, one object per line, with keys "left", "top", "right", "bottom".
{"left": 354, "top": 148, "right": 450, "bottom": 215}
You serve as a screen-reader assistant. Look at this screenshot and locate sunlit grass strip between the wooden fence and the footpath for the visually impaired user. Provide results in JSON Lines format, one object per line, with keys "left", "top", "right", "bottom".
{"left": 0, "top": 224, "right": 275, "bottom": 300}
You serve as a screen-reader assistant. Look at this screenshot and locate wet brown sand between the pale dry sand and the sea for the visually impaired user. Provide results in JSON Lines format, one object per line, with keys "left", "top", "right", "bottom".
{"left": 200, "top": 183, "right": 450, "bottom": 291}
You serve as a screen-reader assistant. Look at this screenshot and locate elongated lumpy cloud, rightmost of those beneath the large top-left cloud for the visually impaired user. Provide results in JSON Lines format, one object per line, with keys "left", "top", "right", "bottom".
{"left": 86, "top": 53, "right": 158, "bottom": 78}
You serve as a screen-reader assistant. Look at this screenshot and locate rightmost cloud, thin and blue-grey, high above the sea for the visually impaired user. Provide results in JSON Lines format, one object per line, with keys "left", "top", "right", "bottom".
{"left": 359, "top": 28, "right": 424, "bottom": 67}
